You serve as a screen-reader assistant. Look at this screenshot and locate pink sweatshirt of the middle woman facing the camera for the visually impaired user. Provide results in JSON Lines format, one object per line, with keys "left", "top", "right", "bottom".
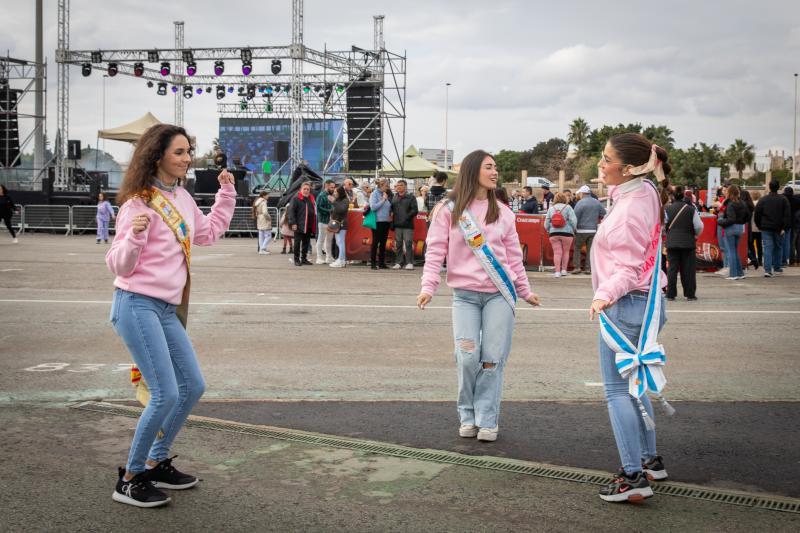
{"left": 422, "top": 200, "right": 531, "bottom": 300}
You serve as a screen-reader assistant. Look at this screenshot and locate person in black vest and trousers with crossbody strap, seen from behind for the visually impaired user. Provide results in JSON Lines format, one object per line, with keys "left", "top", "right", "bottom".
{"left": 664, "top": 185, "right": 703, "bottom": 301}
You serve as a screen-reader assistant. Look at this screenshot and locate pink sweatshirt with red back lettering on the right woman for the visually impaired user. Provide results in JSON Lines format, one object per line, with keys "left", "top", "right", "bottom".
{"left": 591, "top": 179, "right": 667, "bottom": 302}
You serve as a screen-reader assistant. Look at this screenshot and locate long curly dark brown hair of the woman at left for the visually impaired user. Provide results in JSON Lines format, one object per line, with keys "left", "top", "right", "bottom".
{"left": 117, "top": 124, "right": 192, "bottom": 205}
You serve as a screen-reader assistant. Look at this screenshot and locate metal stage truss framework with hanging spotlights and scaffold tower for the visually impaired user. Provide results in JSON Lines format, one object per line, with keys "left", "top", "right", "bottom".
{"left": 56, "top": 0, "right": 406, "bottom": 188}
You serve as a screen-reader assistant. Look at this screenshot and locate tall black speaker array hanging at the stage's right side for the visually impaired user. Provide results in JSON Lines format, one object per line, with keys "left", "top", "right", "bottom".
{"left": 347, "top": 82, "right": 383, "bottom": 170}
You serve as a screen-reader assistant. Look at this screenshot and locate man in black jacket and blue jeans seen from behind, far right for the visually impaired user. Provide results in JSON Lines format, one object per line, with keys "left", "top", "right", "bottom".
{"left": 755, "top": 180, "right": 792, "bottom": 278}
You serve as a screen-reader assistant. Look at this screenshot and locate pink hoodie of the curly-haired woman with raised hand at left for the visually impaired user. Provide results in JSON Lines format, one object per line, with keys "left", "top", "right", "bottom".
{"left": 106, "top": 184, "right": 236, "bottom": 305}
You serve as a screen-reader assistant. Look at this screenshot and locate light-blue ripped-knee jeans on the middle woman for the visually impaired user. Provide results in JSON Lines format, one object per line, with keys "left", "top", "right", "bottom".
{"left": 453, "top": 289, "right": 514, "bottom": 428}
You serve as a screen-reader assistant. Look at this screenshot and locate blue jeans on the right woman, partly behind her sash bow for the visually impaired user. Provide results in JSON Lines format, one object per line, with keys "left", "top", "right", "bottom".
{"left": 600, "top": 293, "right": 667, "bottom": 474}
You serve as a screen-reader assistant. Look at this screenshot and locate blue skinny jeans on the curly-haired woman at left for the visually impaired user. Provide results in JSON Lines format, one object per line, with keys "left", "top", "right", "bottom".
{"left": 111, "top": 289, "right": 205, "bottom": 473}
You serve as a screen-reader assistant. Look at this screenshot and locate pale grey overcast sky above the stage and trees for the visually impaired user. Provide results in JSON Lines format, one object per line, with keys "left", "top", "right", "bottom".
{"left": 0, "top": 0, "right": 800, "bottom": 161}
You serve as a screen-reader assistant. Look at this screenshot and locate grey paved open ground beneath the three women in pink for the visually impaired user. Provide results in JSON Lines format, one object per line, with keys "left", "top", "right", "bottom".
{"left": 0, "top": 234, "right": 800, "bottom": 531}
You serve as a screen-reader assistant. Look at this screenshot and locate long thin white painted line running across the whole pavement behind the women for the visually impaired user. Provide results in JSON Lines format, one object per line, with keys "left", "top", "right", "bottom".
{"left": 0, "top": 299, "right": 800, "bottom": 315}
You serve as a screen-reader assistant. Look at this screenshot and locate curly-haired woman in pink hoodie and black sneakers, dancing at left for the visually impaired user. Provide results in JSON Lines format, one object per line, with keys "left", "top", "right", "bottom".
{"left": 106, "top": 124, "right": 236, "bottom": 507}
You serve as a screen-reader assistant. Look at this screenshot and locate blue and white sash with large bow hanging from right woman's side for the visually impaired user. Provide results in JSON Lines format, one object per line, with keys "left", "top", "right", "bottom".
{"left": 600, "top": 225, "right": 675, "bottom": 429}
